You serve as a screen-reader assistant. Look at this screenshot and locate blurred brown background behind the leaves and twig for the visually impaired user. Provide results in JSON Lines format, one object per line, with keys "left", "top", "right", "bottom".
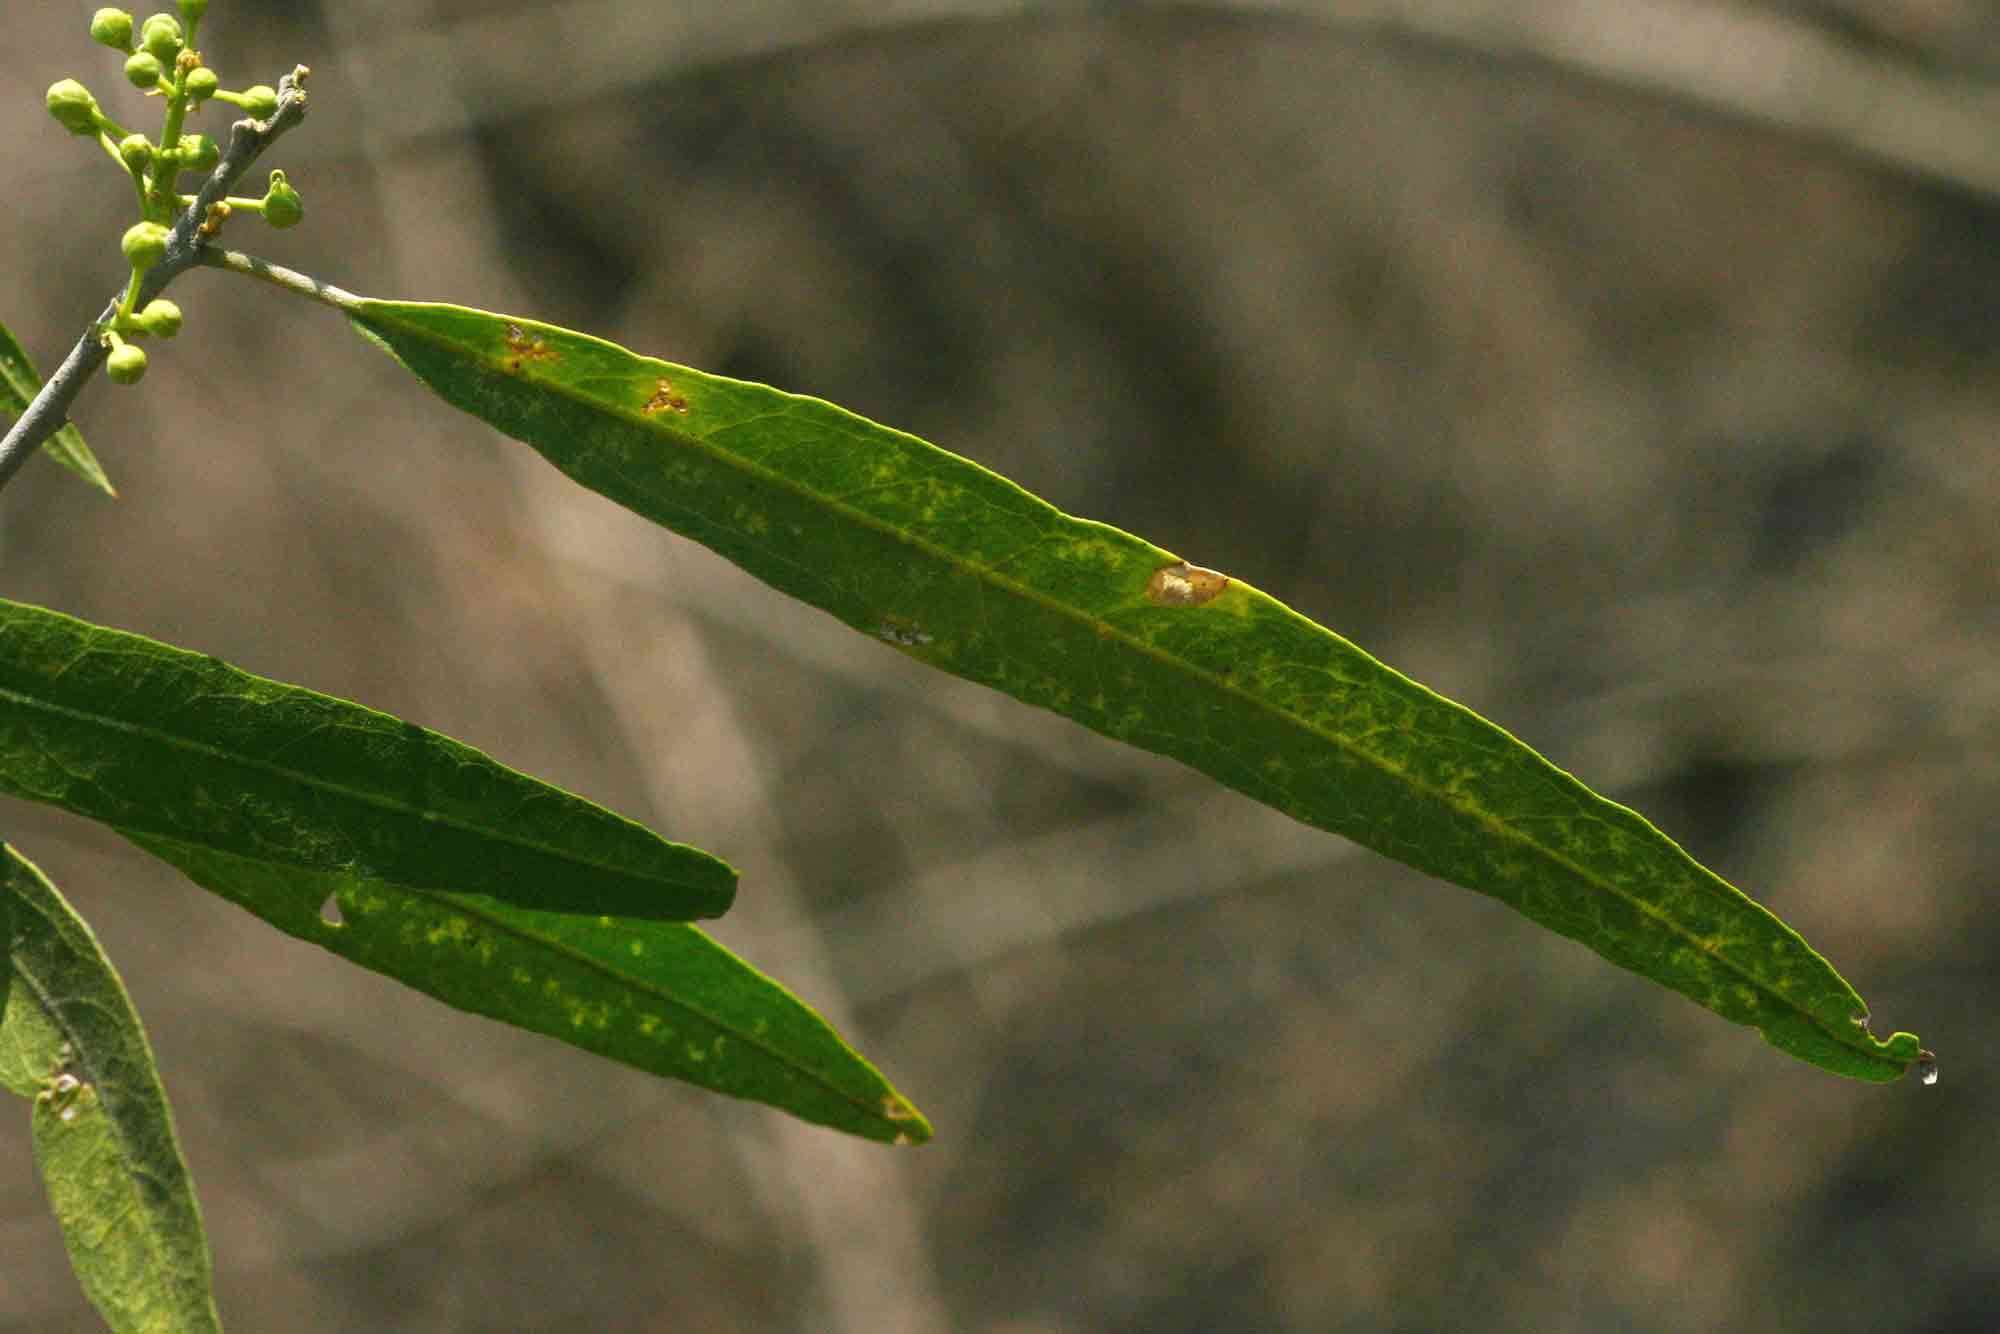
{"left": 0, "top": 0, "right": 2000, "bottom": 1334}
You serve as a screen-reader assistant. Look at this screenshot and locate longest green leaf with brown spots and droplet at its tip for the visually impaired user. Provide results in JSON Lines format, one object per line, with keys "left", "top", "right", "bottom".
{"left": 342, "top": 300, "right": 1918, "bottom": 1080}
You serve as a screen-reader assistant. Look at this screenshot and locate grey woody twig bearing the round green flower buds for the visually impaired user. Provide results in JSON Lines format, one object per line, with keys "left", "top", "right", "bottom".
{"left": 0, "top": 66, "right": 308, "bottom": 498}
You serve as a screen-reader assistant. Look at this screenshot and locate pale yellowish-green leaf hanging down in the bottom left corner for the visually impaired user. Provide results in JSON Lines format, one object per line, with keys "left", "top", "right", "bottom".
{"left": 0, "top": 848, "right": 222, "bottom": 1334}
